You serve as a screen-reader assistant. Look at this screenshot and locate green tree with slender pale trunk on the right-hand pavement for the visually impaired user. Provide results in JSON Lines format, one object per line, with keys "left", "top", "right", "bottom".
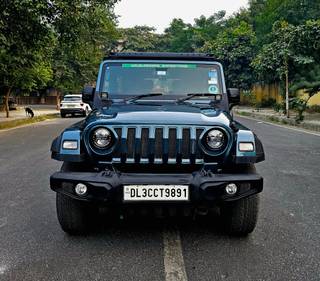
{"left": 252, "top": 21, "right": 320, "bottom": 117}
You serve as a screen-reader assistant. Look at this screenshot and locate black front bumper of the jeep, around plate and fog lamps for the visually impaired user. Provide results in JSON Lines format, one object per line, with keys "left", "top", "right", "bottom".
{"left": 50, "top": 171, "right": 263, "bottom": 205}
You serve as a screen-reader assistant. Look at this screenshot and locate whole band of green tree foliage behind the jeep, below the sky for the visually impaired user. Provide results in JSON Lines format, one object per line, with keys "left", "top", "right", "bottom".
{"left": 0, "top": 0, "right": 320, "bottom": 115}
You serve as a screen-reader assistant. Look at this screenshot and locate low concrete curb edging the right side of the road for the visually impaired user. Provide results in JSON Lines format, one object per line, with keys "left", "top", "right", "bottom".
{"left": 234, "top": 109, "right": 320, "bottom": 132}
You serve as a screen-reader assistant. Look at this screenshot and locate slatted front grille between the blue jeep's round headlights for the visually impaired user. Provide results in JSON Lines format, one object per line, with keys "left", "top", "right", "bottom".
{"left": 112, "top": 126, "right": 205, "bottom": 164}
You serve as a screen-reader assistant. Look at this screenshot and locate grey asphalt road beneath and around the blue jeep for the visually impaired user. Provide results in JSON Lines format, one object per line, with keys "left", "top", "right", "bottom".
{"left": 0, "top": 118, "right": 320, "bottom": 281}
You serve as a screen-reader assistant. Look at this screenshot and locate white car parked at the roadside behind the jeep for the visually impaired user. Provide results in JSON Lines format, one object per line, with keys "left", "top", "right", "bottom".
{"left": 60, "top": 95, "right": 91, "bottom": 118}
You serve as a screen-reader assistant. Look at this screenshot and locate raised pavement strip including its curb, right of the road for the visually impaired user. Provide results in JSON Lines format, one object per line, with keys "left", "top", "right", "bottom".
{"left": 233, "top": 106, "right": 320, "bottom": 132}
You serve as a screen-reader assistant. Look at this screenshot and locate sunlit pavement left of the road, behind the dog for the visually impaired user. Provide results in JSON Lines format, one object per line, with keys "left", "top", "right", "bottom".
{"left": 0, "top": 105, "right": 59, "bottom": 123}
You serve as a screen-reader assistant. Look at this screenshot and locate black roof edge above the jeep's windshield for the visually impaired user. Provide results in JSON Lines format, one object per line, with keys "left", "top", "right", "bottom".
{"left": 104, "top": 52, "right": 219, "bottom": 61}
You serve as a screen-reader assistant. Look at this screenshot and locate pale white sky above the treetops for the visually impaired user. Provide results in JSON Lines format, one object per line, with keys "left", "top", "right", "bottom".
{"left": 115, "top": 0, "right": 248, "bottom": 33}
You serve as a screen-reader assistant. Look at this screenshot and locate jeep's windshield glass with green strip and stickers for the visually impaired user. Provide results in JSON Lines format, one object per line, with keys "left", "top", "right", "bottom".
{"left": 102, "top": 62, "right": 222, "bottom": 98}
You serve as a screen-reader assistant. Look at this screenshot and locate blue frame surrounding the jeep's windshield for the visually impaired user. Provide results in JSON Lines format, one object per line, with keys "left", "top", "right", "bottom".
{"left": 97, "top": 60, "right": 226, "bottom": 100}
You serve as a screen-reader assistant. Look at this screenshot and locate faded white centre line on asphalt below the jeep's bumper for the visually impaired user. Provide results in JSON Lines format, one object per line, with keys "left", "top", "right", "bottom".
{"left": 163, "top": 225, "right": 188, "bottom": 281}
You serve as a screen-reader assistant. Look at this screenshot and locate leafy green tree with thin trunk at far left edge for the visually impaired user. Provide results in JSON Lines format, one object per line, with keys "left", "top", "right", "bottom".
{"left": 0, "top": 0, "right": 53, "bottom": 117}
